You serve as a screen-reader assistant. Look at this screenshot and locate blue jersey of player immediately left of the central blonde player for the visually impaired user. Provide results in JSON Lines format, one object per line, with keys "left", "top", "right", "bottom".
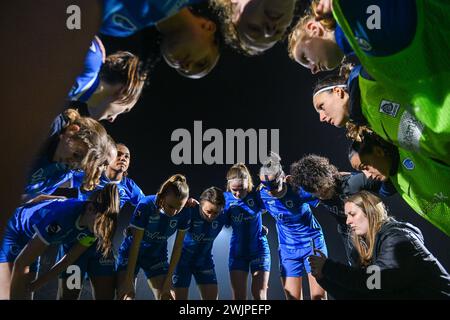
{"left": 183, "top": 205, "right": 228, "bottom": 260}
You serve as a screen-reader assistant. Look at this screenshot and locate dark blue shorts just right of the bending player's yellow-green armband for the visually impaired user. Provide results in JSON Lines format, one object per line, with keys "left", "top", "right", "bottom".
{"left": 58, "top": 242, "right": 116, "bottom": 279}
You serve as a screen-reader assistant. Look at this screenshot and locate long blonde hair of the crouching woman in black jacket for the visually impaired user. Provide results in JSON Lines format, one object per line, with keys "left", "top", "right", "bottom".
{"left": 344, "top": 191, "right": 389, "bottom": 267}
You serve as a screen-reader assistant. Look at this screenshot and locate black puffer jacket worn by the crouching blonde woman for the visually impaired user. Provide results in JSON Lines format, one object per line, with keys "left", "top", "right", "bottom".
{"left": 318, "top": 219, "right": 450, "bottom": 299}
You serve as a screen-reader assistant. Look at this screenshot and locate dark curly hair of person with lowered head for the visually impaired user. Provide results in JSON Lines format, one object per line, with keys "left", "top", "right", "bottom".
{"left": 289, "top": 154, "right": 340, "bottom": 193}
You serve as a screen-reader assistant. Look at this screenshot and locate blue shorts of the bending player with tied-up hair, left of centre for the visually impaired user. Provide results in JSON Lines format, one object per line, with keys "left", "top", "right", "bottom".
{"left": 116, "top": 247, "right": 169, "bottom": 279}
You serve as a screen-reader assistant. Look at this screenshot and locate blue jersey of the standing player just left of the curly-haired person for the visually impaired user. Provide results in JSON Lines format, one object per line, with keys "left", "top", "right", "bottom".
{"left": 260, "top": 184, "right": 323, "bottom": 249}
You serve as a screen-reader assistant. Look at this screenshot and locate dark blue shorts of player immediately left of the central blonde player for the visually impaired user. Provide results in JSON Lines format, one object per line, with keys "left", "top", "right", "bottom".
{"left": 172, "top": 250, "right": 217, "bottom": 288}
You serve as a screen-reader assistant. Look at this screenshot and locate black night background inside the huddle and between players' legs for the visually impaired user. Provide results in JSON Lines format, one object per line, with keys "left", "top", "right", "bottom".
{"left": 37, "top": 26, "right": 450, "bottom": 299}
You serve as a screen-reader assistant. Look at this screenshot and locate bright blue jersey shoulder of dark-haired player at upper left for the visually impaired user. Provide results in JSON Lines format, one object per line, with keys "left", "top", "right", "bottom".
{"left": 68, "top": 38, "right": 104, "bottom": 102}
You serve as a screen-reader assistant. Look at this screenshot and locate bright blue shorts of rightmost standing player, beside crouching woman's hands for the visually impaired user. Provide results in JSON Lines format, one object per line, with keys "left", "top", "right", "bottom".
{"left": 278, "top": 237, "right": 328, "bottom": 278}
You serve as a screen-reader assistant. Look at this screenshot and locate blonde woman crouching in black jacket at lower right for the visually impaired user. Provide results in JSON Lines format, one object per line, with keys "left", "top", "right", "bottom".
{"left": 309, "top": 191, "right": 450, "bottom": 299}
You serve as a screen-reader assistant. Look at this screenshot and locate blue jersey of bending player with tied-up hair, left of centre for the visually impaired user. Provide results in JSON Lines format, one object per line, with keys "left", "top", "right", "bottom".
{"left": 122, "top": 195, "right": 192, "bottom": 255}
